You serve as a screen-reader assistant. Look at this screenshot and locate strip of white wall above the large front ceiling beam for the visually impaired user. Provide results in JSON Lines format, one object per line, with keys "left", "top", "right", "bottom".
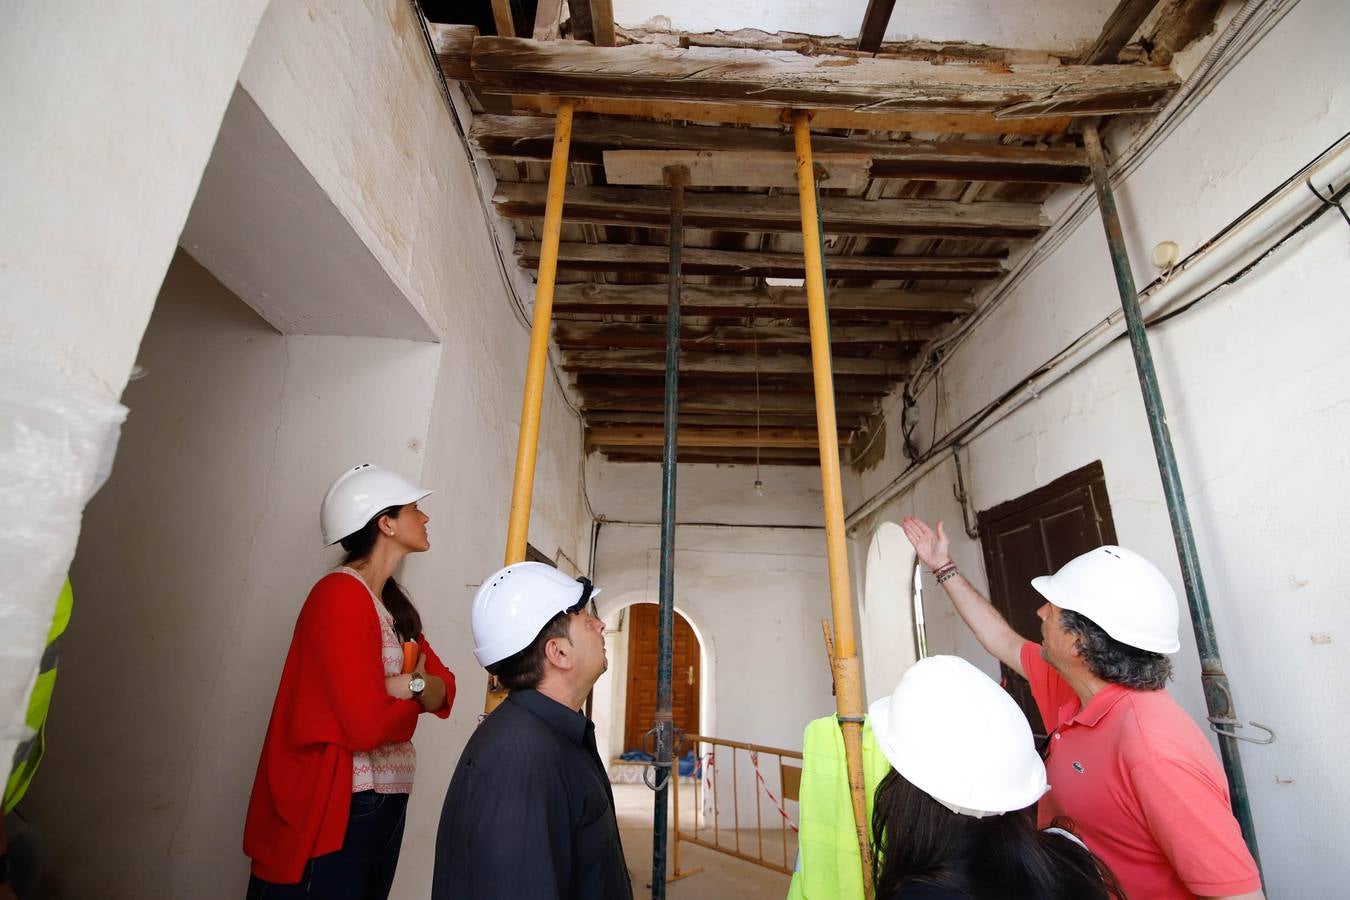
{"left": 614, "top": 0, "right": 1115, "bottom": 51}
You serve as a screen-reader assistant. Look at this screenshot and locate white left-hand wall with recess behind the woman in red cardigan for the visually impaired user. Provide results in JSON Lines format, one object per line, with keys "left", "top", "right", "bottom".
{"left": 13, "top": 0, "right": 589, "bottom": 900}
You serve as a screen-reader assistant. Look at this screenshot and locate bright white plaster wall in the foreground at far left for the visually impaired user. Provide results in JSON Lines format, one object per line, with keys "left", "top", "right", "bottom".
{"left": 0, "top": 0, "right": 266, "bottom": 777}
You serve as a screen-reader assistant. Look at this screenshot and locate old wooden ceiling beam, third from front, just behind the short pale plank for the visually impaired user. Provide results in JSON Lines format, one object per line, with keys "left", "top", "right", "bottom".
{"left": 493, "top": 182, "right": 1049, "bottom": 237}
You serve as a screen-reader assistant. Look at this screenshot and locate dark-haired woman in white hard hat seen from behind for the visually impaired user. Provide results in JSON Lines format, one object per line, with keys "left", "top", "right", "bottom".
{"left": 868, "top": 656, "right": 1123, "bottom": 900}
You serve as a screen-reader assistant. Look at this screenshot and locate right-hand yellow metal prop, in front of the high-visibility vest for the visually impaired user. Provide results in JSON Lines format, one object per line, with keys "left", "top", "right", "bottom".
{"left": 792, "top": 112, "right": 873, "bottom": 899}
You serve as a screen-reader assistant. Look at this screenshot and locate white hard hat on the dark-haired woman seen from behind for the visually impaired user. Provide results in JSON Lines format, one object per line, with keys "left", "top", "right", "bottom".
{"left": 868, "top": 656, "right": 1050, "bottom": 819}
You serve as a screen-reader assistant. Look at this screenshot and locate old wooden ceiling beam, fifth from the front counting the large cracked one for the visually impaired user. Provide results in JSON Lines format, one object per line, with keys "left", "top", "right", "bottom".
{"left": 554, "top": 285, "right": 975, "bottom": 321}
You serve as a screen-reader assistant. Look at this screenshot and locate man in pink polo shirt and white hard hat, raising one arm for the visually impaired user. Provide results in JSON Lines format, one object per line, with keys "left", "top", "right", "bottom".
{"left": 903, "top": 517, "right": 1265, "bottom": 900}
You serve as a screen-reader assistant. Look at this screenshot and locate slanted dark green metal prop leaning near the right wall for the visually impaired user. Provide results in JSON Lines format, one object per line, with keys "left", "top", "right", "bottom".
{"left": 1083, "top": 124, "right": 1261, "bottom": 868}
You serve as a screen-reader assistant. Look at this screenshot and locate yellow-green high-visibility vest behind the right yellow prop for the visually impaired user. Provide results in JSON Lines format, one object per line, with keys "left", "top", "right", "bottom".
{"left": 787, "top": 715, "right": 891, "bottom": 900}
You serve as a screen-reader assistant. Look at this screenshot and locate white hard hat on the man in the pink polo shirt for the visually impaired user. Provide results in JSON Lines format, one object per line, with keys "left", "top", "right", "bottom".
{"left": 1031, "top": 544, "right": 1181, "bottom": 653}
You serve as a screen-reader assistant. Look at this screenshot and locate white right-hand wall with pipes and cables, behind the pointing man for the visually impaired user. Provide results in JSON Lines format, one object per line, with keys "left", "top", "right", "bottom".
{"left": 849, "top": 0, "right": 1350, "bottom": 896}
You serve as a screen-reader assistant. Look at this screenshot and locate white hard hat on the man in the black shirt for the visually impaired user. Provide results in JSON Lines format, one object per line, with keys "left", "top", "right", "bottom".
{"left": 470, "top": 563, "right": 599, "bottom": 668}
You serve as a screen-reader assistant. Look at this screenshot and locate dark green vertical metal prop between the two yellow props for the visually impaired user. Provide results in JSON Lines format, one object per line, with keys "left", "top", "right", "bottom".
{"left": 652, "top": 166, "right": 689, "bottom": 900}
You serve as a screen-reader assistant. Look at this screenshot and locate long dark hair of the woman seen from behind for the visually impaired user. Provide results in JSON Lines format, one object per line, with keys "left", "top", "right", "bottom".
{"left": 872, "top": 769, "right": 1125, "bottom": 900}
